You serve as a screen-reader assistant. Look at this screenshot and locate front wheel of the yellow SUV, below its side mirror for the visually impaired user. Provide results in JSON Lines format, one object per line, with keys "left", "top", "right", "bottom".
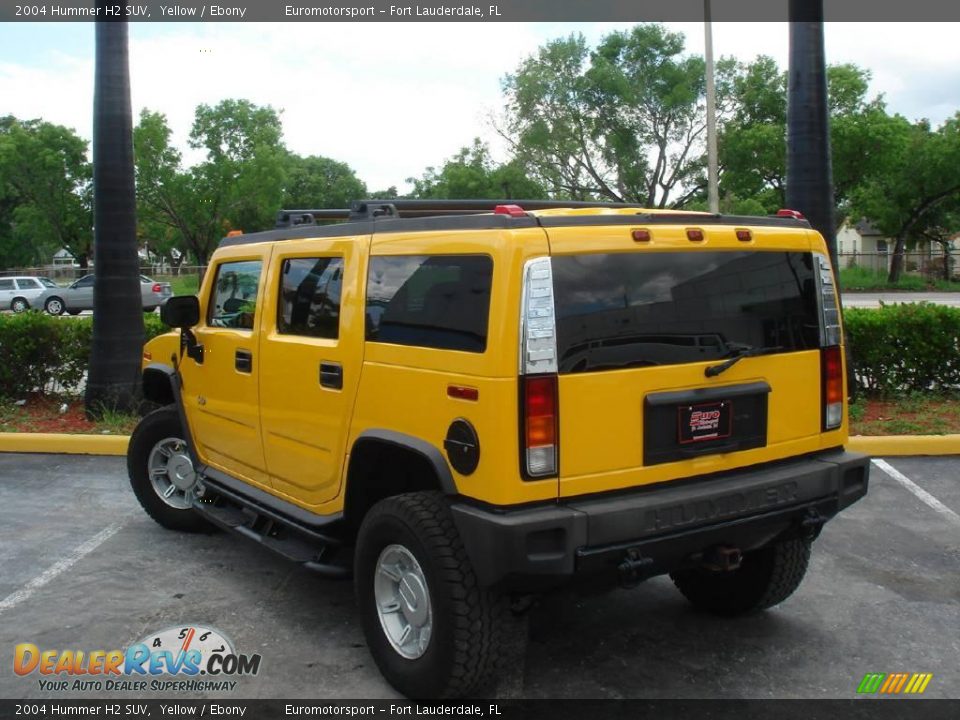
{"left": 127, "top": 406, "right": 212, "bottom": 532}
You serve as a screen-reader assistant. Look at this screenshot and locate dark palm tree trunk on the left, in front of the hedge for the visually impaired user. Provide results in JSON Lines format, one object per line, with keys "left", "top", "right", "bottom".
{"left": 84, "top": 16, "right": 144, "bottom": 417}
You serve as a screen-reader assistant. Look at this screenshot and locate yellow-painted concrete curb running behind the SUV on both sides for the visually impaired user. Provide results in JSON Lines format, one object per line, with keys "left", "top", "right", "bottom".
{"left": 0, "top": 433, "right": 960, "bottom": 457}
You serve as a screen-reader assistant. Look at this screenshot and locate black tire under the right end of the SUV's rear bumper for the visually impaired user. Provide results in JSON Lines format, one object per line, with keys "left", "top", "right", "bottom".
{"left": 670, "top": 539, "right": 810, "bottom": 617}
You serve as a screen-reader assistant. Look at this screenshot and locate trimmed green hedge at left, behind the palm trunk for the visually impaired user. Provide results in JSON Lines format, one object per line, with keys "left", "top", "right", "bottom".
{"left": 0, "top": 311, "right": 168, "bottom": 397}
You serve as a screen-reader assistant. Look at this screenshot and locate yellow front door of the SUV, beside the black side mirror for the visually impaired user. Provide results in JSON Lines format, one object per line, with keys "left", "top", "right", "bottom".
{"left": 180, "top": 253, "right": 269, "bottom": 487}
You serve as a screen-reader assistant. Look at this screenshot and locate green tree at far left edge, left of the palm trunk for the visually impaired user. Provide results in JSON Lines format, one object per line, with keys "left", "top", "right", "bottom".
{"left": 0, "top": 116, "right": 93, "bottom": 268}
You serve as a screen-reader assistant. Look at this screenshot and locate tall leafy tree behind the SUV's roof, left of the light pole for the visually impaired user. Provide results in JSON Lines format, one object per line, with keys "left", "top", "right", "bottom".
{"left": 500, "top": 24, "right": 736, "bottom": 207}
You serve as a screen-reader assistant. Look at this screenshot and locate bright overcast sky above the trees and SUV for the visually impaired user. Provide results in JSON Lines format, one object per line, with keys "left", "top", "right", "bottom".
{"left": 0, "top": 23, "right": 960, "bottom": 192}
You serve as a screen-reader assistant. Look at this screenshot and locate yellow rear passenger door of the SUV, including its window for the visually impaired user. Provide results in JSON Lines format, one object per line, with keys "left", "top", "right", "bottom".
{"left": 260, "top": 237, "right": 369, "bottom": 507}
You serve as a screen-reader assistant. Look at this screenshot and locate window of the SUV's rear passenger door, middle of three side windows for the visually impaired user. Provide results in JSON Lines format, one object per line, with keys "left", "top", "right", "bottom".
{"left": 277, "top": 257, "right": 343, "bottom": 339}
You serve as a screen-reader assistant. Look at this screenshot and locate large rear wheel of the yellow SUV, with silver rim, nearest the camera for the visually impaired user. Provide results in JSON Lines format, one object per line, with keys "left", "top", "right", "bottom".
{"left": 354, "top": 492, "right": 506, "bottom": 698}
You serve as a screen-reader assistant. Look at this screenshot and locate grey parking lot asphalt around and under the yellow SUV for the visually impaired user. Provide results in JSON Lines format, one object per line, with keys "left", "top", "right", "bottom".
{"left": 0, "top": 454, "right": 960, "bottom": 699}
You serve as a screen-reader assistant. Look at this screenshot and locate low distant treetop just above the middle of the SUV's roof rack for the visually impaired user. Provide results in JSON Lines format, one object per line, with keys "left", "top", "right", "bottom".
{"left": 407, "top": 138, "right": 546, "bottom": 199}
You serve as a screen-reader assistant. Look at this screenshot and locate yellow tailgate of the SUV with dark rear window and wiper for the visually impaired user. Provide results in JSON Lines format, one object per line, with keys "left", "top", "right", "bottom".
{"left": 549, "top": 226, "right": 839, "bottom": 496}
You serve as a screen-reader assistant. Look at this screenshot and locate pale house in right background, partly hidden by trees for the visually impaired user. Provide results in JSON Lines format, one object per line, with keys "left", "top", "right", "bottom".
{"left": 837, "top": 220, "right": 960, "bottom": 273}
